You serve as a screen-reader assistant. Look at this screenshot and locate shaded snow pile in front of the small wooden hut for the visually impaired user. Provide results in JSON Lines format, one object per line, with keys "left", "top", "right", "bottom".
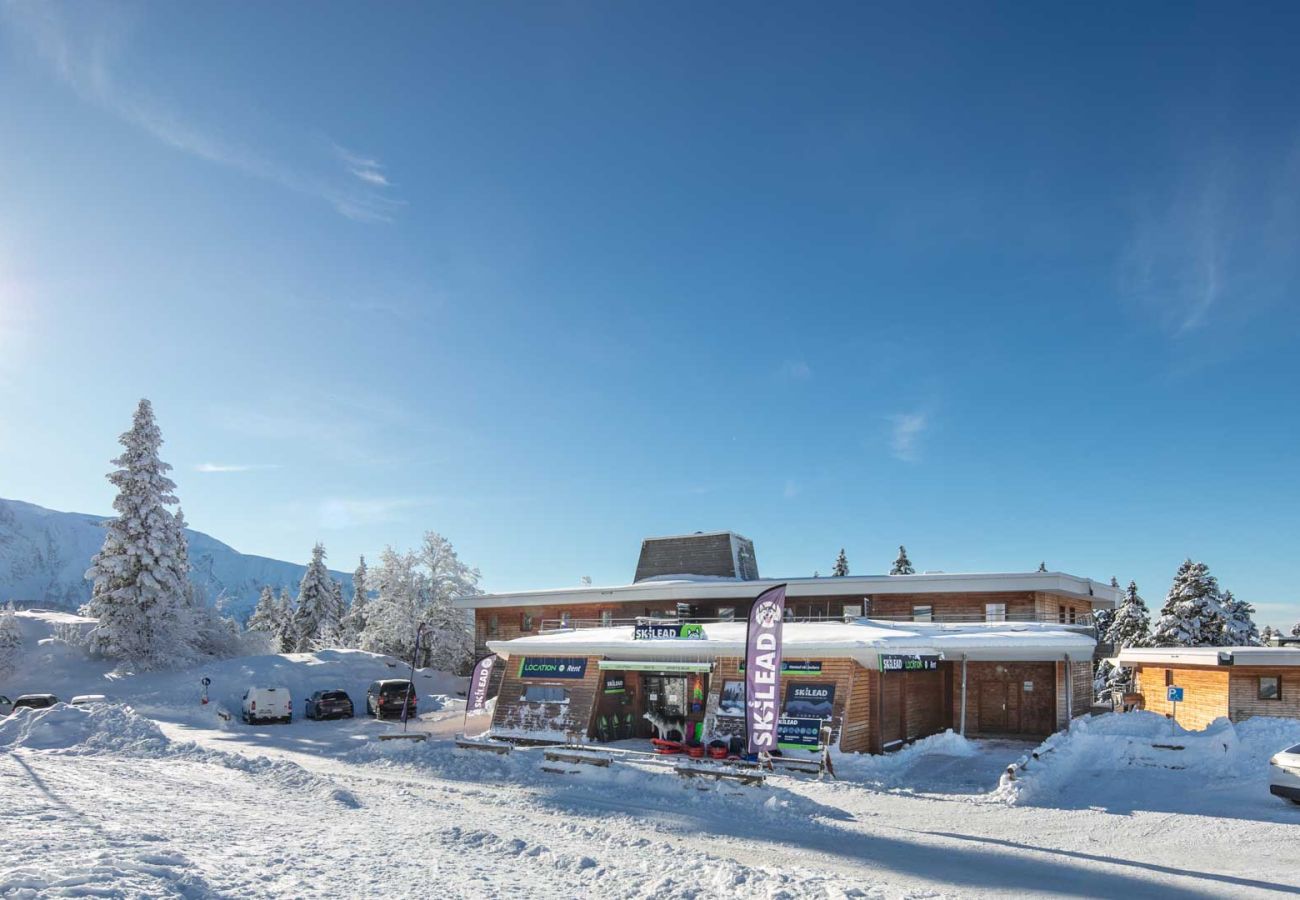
{"left": 995, "top": 711, "right": 1300, "bottom": 804}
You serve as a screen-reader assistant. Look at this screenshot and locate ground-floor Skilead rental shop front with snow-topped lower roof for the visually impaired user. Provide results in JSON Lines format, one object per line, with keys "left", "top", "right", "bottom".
{"left": 488, "top": 619, "right": 1096, "bottom": 753}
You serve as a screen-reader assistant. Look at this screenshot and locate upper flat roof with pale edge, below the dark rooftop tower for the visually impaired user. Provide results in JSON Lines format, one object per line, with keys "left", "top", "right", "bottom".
{"left": 454, "top": 572, "right": 1121, "bottom": 610}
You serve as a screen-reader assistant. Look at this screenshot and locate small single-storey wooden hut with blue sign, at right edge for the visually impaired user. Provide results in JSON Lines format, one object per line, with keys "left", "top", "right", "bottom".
{"left": 1119, "top": 646, "right": 1300, "bottom": 730}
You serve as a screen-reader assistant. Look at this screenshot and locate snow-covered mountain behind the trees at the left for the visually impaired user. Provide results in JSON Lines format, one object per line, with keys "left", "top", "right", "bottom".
{"left": 0, "top": 498, "right": 352, "bottom": 620}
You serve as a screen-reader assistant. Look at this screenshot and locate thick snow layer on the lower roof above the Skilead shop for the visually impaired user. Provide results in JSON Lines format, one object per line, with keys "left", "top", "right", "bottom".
{"left": 488, "top": 619, "right": 1096, "bottom": 665}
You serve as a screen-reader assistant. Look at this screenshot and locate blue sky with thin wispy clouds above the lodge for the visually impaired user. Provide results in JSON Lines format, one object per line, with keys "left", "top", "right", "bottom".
{"left": 0, "top": 1, "right": 1300, "bottom": 624}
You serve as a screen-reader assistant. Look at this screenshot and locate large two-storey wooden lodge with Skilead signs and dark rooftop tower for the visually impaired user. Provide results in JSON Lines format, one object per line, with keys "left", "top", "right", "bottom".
{"left": 456, "top": 532, "right": 1118, "bottom": 753}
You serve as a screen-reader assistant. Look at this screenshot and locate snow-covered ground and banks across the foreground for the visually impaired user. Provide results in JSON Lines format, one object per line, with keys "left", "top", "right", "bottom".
{"left": 0, "top": 608, "right": 1300, "bottom": 899}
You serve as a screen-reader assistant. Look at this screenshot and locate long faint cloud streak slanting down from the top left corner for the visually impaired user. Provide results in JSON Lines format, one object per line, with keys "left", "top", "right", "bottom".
{"left": 0, "top": 3, "right": 402, "bottom": 222}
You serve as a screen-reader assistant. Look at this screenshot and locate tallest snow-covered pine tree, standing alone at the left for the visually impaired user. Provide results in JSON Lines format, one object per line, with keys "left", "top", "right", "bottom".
{"left": 82, "top": 399, "right": 185, "bottom": 668}
